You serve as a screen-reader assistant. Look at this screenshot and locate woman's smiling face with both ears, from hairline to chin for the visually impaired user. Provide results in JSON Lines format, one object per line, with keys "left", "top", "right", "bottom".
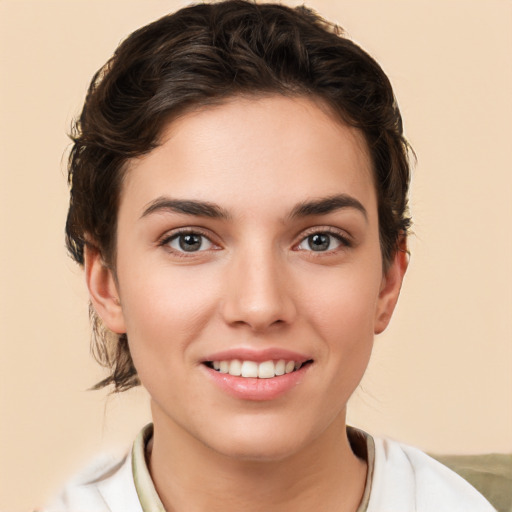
{"left": 87, "top": 96, "right": 405, "bottom": 459}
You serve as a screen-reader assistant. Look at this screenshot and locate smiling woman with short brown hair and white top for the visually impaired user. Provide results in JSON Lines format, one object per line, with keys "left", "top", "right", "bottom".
{"left": 46, "top": 1, "right": 493, "bottom": 512}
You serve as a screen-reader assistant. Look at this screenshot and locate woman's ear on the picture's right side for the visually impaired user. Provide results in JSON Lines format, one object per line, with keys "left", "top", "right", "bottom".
{"left": 374, "top": 237, "right": 409, "bottom": 334}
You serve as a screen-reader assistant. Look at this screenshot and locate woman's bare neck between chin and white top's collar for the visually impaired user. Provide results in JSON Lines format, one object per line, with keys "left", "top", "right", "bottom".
{"left": 149, "top": 404, "right": 367, "bottom": 512}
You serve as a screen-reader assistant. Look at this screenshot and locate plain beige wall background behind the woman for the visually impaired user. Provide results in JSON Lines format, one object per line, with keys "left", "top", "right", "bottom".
{"left": 0, "top": 0, "right": 512, "bottom": 511}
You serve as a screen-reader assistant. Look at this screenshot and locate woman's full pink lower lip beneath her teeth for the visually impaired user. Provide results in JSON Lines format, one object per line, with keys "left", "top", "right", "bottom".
{"left": 202, "top": 364, "right": 311, "bottom": 401}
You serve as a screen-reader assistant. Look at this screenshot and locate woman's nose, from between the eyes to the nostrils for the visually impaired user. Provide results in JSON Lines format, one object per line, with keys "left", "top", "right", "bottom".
{"left": 222, "top": 245, "right": 297, "bottom": 332}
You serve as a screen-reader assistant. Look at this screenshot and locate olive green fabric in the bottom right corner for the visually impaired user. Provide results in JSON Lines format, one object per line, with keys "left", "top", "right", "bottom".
{"left": 431, "top": 453, "right": 512, "bottom": 512}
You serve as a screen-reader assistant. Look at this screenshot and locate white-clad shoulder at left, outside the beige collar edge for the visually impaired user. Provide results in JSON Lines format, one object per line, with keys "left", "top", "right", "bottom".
{"left": 41, "top": 455, "right": 142, "bottom": 512}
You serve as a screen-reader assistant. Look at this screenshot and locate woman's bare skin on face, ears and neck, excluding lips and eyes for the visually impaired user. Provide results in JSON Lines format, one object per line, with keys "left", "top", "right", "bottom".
{"left": 86, "top": 95, "right": 407, "bottom": 511}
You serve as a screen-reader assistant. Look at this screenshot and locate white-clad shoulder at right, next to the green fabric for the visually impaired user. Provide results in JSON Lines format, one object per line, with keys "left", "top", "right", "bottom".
{"left": 368, "top": 438, "right": 495, "bottom": 512}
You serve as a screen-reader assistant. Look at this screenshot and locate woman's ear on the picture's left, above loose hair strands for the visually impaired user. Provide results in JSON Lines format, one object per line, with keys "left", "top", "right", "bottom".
{"left": 84, "top": 245, "right": 126, "bottom": 334}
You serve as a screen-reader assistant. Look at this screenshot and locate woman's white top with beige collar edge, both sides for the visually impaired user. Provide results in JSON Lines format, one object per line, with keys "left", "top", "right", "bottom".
{"left": 41, "top": 425, "right": 496, "bottom": 512}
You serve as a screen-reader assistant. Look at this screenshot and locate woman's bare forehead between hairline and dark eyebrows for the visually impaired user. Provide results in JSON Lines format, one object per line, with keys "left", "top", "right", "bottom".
{"left": 121, "top": 95, "right": 375, "bottom": 219}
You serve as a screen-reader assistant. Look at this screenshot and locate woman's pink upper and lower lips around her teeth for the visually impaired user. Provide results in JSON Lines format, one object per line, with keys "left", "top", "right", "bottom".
{"left": 200, "top": 349, "right": 312, "bottom": 402}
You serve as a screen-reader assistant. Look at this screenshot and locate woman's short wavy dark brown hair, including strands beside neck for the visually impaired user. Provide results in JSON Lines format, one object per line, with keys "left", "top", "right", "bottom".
{"left": 66, "top": 0, "right": 410, "bottom": 391}
